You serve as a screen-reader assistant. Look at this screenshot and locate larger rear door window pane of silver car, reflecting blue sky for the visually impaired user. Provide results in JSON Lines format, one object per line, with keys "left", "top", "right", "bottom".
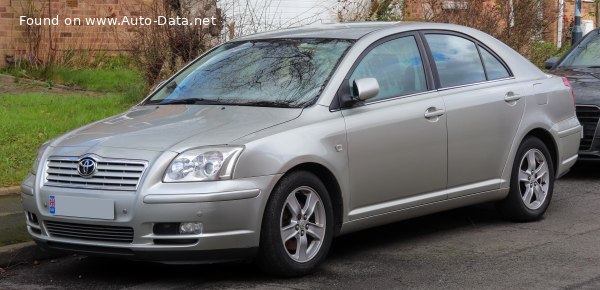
{"left": 425, "top": 34, "right": 486, "bottom": 87}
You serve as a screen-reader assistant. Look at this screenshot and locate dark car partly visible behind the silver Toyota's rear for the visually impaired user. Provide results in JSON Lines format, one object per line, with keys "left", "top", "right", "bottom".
{"left": 545, "top": 28, "right": 600, "bottom": 161}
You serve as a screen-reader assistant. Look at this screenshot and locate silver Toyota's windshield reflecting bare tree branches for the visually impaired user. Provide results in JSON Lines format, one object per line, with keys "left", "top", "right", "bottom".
{"left": 144, "top": 39, "right": 352, "bottom": 107}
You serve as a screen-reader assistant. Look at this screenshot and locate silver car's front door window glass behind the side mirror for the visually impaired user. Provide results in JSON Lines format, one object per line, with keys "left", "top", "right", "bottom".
{"left": 350, "top": 36, "right": 427, "bottom": 100}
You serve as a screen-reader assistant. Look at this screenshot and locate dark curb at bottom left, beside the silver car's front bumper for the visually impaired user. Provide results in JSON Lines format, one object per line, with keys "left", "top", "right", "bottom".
{"left": 0, "top": 242, "right": 65, "bottom": 268}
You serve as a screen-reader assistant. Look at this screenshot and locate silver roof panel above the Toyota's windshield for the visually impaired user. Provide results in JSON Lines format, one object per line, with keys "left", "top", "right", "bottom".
{"left": 233, "top": 21, "right": 411, "bottom": 41}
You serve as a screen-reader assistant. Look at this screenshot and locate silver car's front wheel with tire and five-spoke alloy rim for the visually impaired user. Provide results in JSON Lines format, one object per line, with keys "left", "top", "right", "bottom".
{"left": 257, "top": 171, "right": 335, "bottom": 277}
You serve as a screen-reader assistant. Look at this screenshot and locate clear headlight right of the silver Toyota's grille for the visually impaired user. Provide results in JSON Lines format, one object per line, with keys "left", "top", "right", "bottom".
{"left": 163, "top": 147, "right": 244, "bottom": 182}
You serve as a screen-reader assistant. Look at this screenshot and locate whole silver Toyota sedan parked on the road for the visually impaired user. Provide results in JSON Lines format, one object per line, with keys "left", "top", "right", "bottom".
{"left": 21, "top": 23, "right": 582, "bottom": 276}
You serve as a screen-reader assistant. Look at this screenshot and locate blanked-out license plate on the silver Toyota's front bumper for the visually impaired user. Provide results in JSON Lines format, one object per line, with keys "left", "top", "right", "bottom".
{"left": 50, "top": 195, "right": 115, "bottom": 220}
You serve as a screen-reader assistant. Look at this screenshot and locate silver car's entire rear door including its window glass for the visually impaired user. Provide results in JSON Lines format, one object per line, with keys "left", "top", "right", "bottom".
{"left": 424, "top": 32, "right": 532, "bottom": 198}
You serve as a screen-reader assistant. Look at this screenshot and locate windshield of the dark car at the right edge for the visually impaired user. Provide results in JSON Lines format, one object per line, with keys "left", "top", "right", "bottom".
{"left": 558, "top": 30, "right": 600, "bottom": 67}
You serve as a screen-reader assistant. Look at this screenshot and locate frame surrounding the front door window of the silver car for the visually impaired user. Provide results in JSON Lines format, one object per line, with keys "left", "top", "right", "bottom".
{"left": 329, "top": 31, "right": 436, "bottom": 112}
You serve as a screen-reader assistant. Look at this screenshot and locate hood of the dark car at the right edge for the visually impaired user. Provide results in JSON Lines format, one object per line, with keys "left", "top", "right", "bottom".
{"left": 552, "top": 68, "right": 600, "bottom": 106}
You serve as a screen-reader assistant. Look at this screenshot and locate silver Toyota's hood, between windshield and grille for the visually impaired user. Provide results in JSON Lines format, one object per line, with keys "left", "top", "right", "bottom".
{"left": 52, "top": 105, "right": 302, "bottom": 151}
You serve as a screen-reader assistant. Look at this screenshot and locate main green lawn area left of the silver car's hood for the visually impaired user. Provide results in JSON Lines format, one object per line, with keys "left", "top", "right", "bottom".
{"left": 0, "top": 94, "right": 139, "bottom": 187}
